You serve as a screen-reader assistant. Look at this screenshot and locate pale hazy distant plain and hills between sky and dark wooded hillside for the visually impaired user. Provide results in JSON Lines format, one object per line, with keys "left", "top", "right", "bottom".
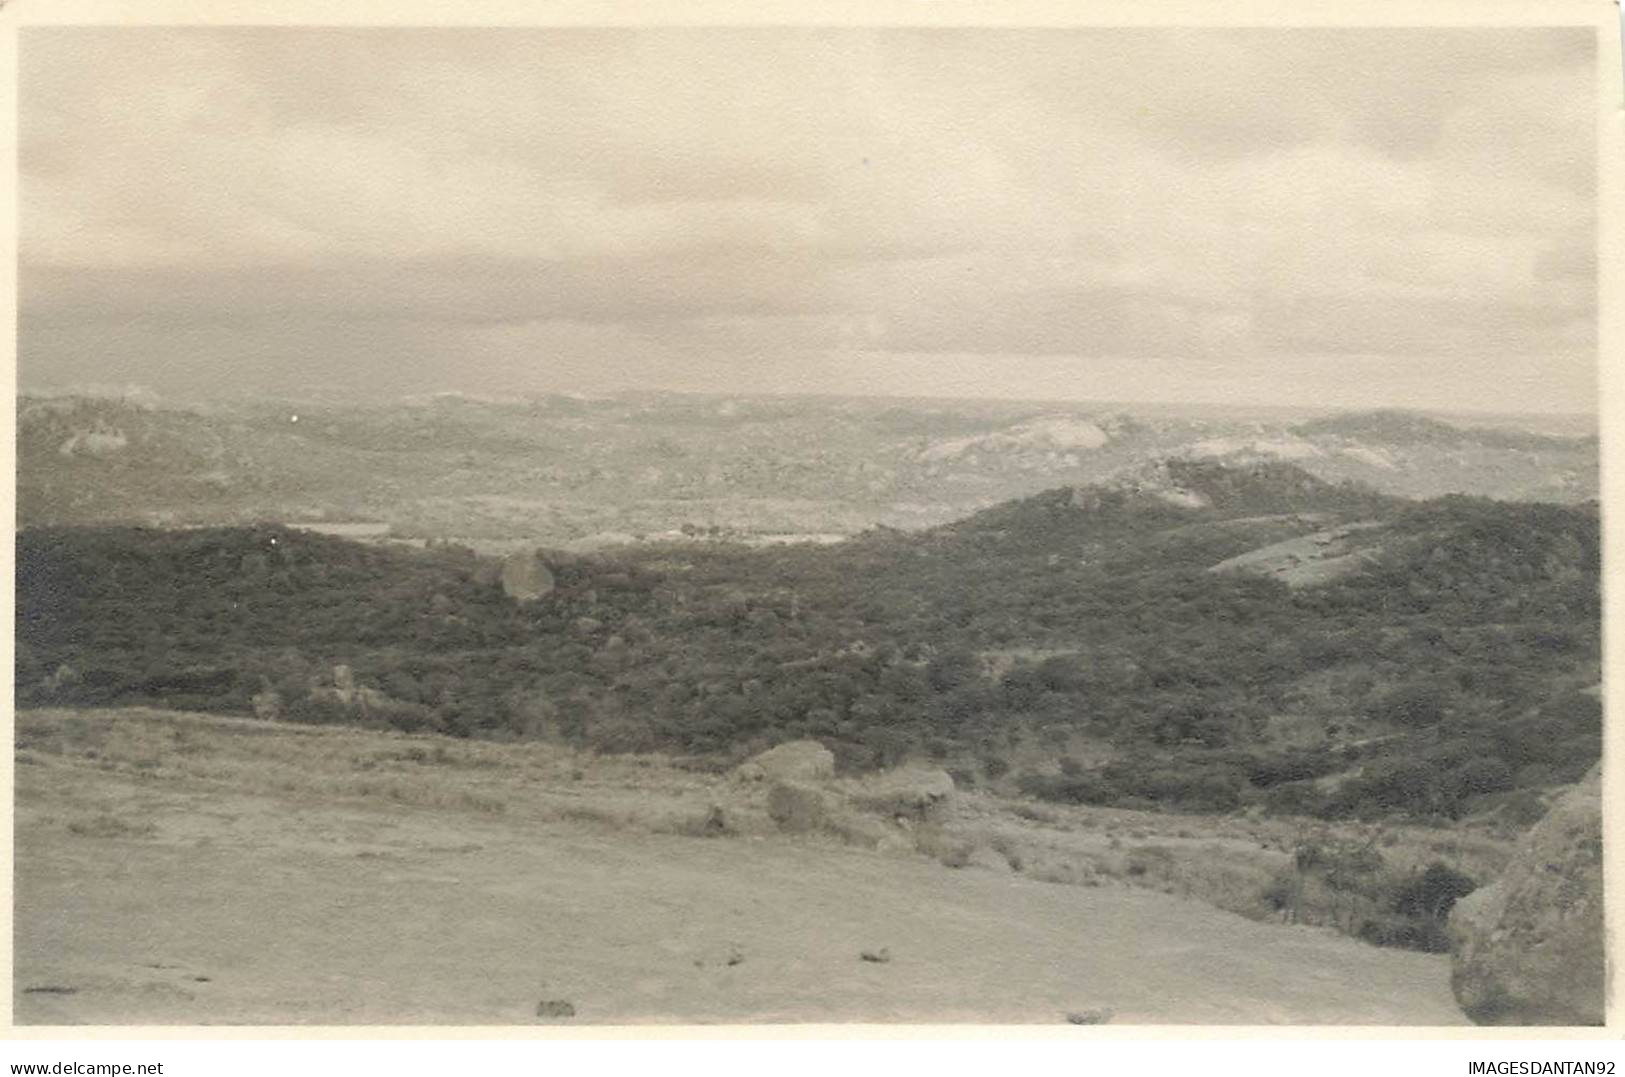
{"left": 18, "top": 395, "right": 1597, "bottom": 551}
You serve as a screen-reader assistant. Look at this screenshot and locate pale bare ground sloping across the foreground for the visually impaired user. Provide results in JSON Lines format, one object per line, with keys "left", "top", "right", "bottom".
{"left": 13, "top": 710, "right": 1466, "bottom": 1025}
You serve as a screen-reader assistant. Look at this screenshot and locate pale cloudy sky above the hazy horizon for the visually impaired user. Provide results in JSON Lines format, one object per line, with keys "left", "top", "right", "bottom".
{"left": 20, "top": 28, "right": 1597, "bottom": 413}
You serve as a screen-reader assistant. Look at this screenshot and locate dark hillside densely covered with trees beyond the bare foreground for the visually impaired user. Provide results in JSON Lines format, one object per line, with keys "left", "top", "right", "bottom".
{"left": 16, "top": 461, "right": 1601, "bottom": 819}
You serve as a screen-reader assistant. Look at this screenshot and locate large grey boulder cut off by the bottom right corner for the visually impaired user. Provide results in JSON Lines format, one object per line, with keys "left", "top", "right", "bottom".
{"left": 1450, "top": 767, "right": 1606, "bottom": 1025}
